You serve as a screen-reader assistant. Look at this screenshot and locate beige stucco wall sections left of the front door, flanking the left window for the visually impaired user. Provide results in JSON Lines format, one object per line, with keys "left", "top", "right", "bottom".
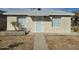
{"left": 7, "top": 16, "right": 35, "bottom": 32}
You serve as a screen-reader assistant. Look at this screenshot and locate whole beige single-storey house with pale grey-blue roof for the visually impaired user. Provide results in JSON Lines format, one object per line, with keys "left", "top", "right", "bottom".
{"left": 2, "top": 9, "right": 74, "bottom": 33}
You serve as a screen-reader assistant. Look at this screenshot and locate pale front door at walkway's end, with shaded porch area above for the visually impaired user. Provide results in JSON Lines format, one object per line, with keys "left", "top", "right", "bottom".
{"left": 35, "top": 16, "right": 44, "bottom": 32}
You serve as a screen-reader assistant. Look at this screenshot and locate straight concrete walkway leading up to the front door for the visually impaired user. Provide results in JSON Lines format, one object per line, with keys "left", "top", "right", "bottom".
{"left": 34, "top": 33, "right": 48, "bottom": 50}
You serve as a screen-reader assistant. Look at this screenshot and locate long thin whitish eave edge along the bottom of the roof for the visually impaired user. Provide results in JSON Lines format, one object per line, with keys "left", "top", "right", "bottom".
{"left": 3, "top": 13, "right": 75, "bottom": 16}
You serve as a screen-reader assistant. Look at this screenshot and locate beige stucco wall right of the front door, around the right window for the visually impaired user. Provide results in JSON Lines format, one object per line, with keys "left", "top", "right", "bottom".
{"left": 44, "top": 17, "right": 71, "bottom": 33}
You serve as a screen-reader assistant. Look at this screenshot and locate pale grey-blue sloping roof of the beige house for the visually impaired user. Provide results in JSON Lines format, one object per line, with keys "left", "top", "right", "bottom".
{"left": 0, "top": 8, "right": 74, "bottom": 16}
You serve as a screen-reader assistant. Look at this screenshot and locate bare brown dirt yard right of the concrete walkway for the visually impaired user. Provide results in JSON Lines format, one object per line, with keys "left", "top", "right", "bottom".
{"left": 46, "top": 35, "right": 79, "bottom": 50}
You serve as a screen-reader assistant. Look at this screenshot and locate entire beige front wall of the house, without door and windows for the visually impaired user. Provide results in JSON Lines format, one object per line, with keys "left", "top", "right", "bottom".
{"left": 7, "top": 16, "right": 71, "bottom": 33}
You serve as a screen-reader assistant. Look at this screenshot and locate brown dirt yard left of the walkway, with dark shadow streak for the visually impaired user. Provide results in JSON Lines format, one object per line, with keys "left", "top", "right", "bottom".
{"left": 0, "top": 35, "right": 34, "bottom": 50}
